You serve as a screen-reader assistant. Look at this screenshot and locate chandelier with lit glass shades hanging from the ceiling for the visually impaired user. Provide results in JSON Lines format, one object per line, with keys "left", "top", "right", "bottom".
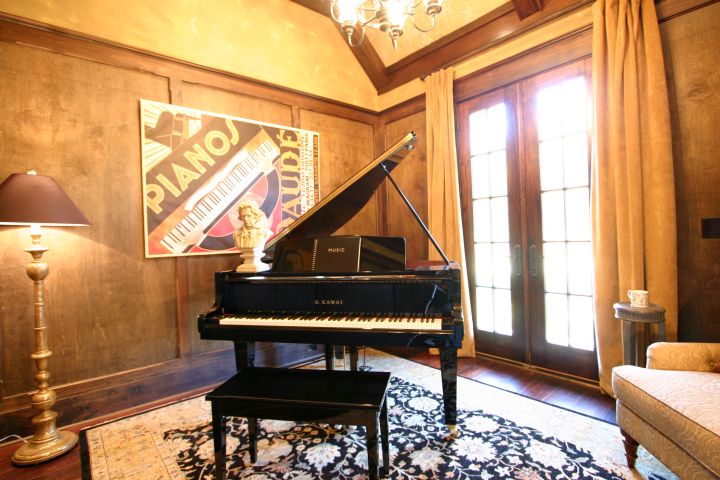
{"left": 330, "top": 0, "right": 442, "bottom": 48}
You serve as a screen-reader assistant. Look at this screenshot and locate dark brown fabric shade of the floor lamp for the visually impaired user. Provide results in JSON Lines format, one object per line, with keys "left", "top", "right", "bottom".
{"left": 0, "top": 172, "right": 90, "bottom": 226}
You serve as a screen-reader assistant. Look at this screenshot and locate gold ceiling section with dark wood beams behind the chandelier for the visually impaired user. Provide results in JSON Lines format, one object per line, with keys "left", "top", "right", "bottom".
{"left": 292, "top": 0, "right": 592, "bottom": 94}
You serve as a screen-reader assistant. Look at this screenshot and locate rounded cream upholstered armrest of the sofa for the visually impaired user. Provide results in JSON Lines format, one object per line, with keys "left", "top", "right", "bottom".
{"left": 647, "top": 342, "right": 720, "bottom": 373}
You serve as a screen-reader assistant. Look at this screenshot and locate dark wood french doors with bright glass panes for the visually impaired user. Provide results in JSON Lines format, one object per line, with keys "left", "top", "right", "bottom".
{"left": 458, "top": 61, "right": 597, "bottom": 378}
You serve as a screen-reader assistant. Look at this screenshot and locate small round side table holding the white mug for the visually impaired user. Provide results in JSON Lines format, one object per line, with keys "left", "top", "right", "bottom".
{"left": 613, "top": 302, "right": 665, "bottom": 367}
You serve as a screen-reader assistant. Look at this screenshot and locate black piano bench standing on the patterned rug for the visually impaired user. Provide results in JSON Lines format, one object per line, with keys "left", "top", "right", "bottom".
{"left": 205, "top": 368, "right": 390, "bottom": 480}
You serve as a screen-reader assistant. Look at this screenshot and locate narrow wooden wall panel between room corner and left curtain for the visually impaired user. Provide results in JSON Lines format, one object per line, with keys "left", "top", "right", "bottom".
{"left": 385, "top": 110, "right": 434, "bottom": 260}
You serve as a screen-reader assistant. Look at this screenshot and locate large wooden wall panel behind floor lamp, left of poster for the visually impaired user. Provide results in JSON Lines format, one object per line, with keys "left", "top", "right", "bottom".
{"left": 0, "top": 43, "right": 176, "bottom": 395}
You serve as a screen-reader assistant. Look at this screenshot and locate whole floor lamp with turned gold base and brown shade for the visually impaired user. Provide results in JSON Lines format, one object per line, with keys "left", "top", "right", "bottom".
{"left": 0, "top": 170, "right": 90, "bottom": 465}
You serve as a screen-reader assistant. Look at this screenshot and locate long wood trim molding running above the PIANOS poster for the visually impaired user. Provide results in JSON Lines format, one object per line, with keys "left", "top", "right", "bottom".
{"left": 0, "top": 12, "right": 377, "bottom": 125}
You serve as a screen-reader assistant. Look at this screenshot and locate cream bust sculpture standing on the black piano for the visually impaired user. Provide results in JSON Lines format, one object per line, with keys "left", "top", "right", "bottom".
{"left": 233, "top": 200, "right": 272, "bottom": 272}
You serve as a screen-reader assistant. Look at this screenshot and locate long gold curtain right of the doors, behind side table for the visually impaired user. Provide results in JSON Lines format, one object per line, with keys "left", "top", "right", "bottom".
{"left": 591, "top": 0, "right": 678, "bottom": 393}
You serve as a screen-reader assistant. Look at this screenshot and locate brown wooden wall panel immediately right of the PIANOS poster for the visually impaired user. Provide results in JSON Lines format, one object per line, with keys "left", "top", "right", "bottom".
{"left": 298, "top": 109, "right": 378, "bottom": 235}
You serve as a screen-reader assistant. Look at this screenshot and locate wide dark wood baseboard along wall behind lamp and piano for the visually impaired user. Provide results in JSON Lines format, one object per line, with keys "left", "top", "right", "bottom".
{"left": 0, "top": 343, "right": 324, "bottom": 437}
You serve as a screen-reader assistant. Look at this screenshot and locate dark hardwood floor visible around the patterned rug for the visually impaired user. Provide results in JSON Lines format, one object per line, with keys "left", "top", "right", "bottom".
{"left": 0, "top": 350, "right": 615, "bottom": 480}
